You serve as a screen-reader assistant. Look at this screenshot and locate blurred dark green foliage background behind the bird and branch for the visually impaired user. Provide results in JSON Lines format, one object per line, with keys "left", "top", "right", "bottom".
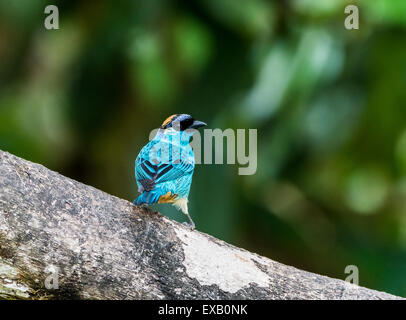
{"left": 0, "top": 0, "right": 406, "bottom": 296}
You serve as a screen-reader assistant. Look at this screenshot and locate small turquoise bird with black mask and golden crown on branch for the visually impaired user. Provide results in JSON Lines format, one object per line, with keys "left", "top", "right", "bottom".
{"left": 134, "top": 114, "right": 206, "bottom": 229}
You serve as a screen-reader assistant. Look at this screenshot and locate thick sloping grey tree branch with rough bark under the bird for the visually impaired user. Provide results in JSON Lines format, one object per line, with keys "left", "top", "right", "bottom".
{"left": 0, "top": 151, "right": 397, "bottom": 299}
